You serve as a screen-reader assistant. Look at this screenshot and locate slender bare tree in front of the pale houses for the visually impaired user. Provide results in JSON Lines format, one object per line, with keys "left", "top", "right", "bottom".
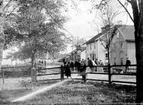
{"left": 96, "top": 2, "right": 123, "bottom": 84}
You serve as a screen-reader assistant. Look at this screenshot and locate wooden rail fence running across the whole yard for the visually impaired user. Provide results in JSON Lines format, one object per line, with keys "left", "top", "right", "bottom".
{"left": 1, "top": 65, "right": 136, "bottom": 84}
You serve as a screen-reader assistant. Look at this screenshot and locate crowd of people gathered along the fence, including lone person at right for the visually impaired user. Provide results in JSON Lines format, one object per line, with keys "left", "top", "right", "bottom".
{"left": 62, "top": 58, "right": 131, "bottom": 82}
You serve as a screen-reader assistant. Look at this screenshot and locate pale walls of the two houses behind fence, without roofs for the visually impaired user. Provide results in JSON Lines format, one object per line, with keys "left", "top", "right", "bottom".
{"left": 86, "top": 27, "right": 136, "bottom": 65}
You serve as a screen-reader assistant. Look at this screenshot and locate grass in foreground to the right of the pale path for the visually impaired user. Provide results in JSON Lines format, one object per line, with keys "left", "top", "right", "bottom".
{"left": 0, "top": 81, "right": 136, "bottom": 105}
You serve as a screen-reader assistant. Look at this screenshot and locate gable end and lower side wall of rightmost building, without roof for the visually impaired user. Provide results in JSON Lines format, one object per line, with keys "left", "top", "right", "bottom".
{"left": 110, "top": 29, "right": 136, "bottom": 65}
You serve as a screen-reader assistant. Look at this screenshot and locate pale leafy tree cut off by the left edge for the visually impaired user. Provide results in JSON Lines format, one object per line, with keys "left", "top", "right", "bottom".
{"left": 0, "top": 0, "right": 17, "bottom": 69}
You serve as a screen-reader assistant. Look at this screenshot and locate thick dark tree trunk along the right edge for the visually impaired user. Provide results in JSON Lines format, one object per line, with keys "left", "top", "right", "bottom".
{"left": 135, "top": 13, "right": 143, "bottom": 103}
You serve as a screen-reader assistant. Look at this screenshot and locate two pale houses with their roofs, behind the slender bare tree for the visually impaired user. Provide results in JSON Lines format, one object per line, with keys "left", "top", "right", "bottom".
{"left": 86, "top": 25, "right": 136, "bottom": 65}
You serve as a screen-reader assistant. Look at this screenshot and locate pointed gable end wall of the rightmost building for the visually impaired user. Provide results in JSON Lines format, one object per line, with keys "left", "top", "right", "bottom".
{"left": 110, "top": 31, "right": 127, "bottom": 65}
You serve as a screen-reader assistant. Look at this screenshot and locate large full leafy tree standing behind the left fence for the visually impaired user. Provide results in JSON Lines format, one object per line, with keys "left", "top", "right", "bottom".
{"left": 4, "top": 0, "right": 64, "bottom": 65}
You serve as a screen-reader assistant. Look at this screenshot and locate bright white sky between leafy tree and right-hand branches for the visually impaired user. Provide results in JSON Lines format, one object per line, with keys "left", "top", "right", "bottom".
{"left": 62, "top": 0, "right": 133, "bottom": 52}
